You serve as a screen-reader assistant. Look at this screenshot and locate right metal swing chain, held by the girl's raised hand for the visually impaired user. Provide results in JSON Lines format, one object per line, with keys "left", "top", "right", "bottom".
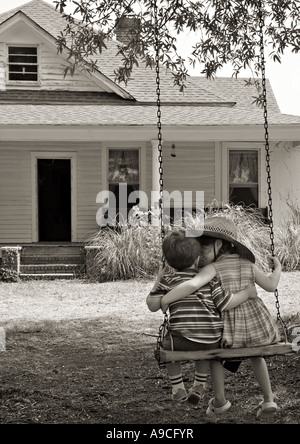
{"left": 258, "top": 1, "right": 287, "bottom": 335}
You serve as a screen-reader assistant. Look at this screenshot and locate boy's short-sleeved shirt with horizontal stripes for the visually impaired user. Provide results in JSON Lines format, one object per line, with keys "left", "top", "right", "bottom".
{"left": 150, "top": 269, "right": 232, "bottom": 344}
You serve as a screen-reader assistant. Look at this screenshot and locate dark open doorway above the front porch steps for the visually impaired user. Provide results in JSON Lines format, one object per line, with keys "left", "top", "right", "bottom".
{"left": 38, "top": 159, "right": 71, "bottom": 242}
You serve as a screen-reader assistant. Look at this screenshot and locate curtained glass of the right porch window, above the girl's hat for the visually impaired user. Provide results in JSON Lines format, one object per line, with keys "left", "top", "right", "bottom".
{"left": 229, "top": 150, "right": 259, "bottom": 207}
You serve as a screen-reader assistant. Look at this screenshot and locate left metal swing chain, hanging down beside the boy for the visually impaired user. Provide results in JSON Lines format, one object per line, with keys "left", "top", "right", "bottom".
{"left": 153, "top": 1, "right": 165, "bottom": 265}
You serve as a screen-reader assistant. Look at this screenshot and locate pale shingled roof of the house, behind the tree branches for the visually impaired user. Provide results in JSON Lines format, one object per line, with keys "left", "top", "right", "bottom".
{"left": 0, "top": 0, "right": 300, "bottom": 126}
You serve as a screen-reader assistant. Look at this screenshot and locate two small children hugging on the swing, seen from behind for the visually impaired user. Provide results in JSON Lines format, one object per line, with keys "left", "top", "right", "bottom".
{"left": 147, "top": 217, "right": 281, "bottom": 418}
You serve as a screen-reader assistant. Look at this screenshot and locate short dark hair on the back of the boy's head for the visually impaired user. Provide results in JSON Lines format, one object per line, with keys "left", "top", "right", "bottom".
{"left": 162, "top": 230, "right": 201, "bottom": 270}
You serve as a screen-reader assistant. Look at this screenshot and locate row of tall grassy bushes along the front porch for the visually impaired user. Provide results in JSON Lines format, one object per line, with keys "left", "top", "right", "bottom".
{"left": 88, "top": 201, "right": 300, "bottom": 282}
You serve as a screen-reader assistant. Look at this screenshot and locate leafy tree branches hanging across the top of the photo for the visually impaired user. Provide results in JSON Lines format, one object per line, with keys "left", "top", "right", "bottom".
{"left": 55, "top": 0, "right": 300, "bottom": 89}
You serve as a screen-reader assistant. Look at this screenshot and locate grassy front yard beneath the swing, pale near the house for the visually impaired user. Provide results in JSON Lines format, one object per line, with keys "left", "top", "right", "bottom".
{"left": 0, "top": 272, "right": 300, "bottom": 424}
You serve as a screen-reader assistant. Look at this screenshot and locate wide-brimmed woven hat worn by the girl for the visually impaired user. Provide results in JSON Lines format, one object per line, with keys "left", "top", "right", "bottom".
{"left": 199, "top": 216, "right": 255, "bottom": 263}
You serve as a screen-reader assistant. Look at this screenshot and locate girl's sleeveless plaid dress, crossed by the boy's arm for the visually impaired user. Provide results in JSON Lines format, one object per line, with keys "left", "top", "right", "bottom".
{"left": 213, "top": 254, "right": 280, "bottom": 348}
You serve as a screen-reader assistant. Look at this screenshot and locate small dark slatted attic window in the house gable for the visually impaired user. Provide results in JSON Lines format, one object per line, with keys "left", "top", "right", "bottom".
{"left": 8, "top": 46, "right": 38, "bottom": 82}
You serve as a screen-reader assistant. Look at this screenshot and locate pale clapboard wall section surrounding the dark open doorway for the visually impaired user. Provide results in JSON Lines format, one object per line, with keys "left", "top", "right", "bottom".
{"left": 0, "top": 142, "right": 101, "bottom": 244}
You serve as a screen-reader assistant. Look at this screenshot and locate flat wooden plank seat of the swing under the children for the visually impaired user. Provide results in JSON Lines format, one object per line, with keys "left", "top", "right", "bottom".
{"left": 159, "top": 342, "right": 294, "bottom": 362}
